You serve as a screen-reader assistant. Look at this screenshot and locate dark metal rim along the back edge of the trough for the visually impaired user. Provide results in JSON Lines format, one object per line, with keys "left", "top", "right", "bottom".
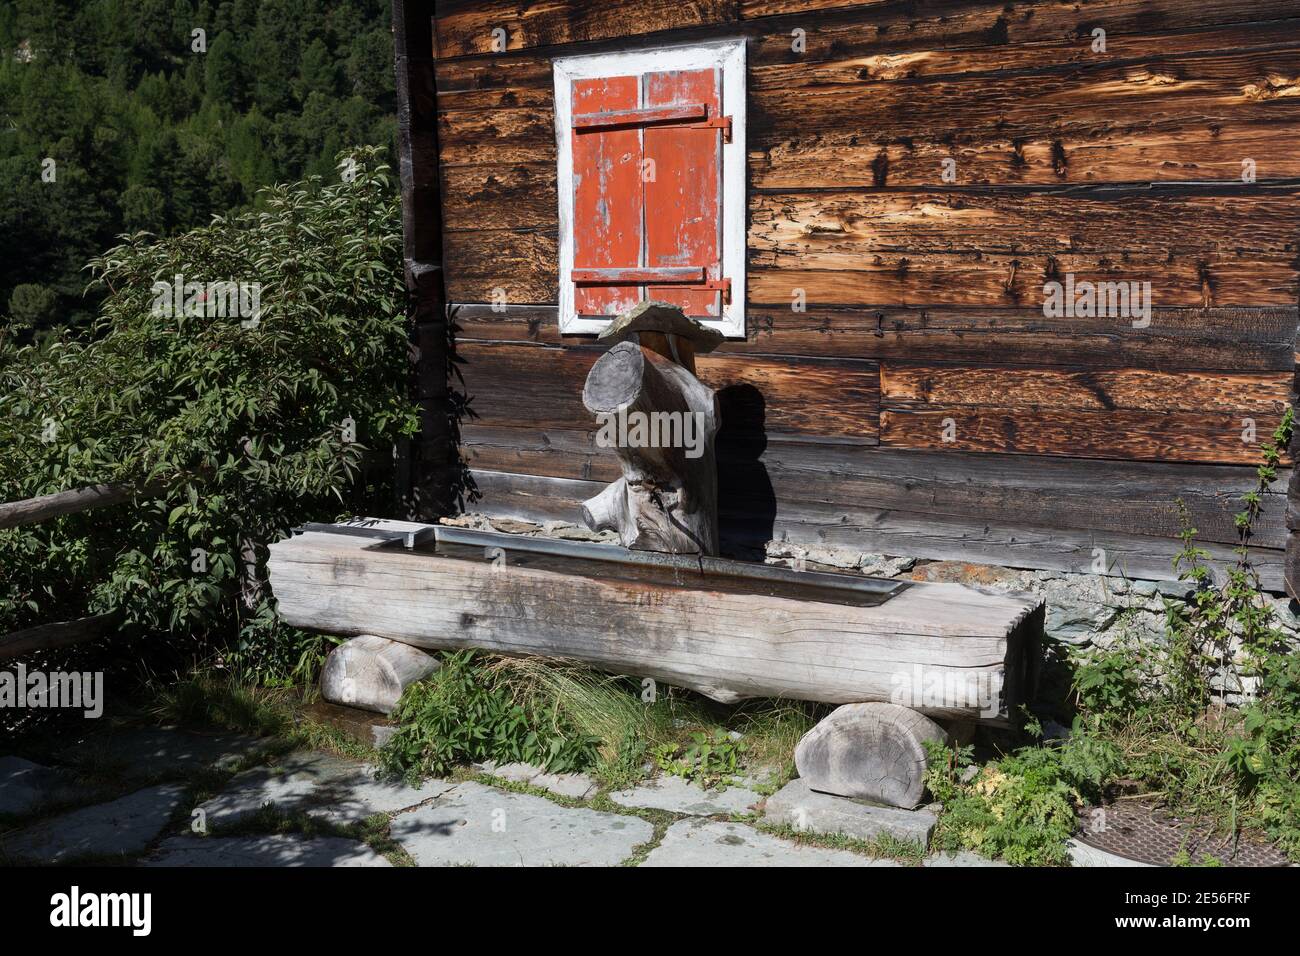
{"left": 294, "top": 523, "right": 911, "bottom": 601}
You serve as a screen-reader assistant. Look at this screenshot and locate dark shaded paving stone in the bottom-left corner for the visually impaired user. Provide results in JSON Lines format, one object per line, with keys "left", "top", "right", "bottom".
{"left": 0, "top": 783, "right": 185, "bottom": 864}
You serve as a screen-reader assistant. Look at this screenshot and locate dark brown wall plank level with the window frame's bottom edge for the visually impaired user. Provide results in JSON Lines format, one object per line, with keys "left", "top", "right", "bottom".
{"left": 454, "top": 303, "right": 1300, "bottom": 372}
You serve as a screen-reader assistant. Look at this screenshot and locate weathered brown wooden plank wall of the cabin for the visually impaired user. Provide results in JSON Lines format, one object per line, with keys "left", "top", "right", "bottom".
{"left": 434, "top": 0, "right": 1300, "bottom": 589}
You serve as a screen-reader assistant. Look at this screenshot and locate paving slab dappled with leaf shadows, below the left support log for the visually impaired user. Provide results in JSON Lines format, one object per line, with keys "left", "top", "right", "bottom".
{"left": 199, "top": 753, "right": 452, "bottom": 827}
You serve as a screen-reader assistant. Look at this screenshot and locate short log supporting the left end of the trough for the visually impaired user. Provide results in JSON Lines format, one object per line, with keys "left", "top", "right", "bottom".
{"left": 321, "top": 635, "right": 439, "bottom": 714}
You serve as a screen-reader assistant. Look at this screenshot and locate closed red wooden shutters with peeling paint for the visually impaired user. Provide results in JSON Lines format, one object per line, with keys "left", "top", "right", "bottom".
{"left": 568, "top": 69, "right": 729, "bottom": 319}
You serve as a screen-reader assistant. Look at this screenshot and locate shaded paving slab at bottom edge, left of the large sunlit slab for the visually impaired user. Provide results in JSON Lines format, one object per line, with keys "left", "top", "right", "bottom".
{"left": 143, "top": 834, "right": 393, "bottom": 866}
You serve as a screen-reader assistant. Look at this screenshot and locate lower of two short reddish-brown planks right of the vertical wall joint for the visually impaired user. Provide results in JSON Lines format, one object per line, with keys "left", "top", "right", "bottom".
{"left": 880, "top": 405, "right": 1282, "bottom": 464}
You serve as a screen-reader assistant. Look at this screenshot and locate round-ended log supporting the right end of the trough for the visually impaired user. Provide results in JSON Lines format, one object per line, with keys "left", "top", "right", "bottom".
{"left": 794, "top": 704, "right": 948, "bottom": 808}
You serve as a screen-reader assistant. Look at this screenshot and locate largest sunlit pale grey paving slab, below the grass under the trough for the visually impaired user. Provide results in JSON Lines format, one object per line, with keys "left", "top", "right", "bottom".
{"left": 390, "top": 782, "right": 654, "bottom": 866}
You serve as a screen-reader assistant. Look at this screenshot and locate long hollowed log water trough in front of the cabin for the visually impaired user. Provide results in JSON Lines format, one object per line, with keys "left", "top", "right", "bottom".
{"left": 270, "top": 520, "right": 1043, "bottom": 724}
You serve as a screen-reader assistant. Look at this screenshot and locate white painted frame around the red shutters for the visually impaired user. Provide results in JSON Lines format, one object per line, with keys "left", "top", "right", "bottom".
{"left": 553, "top": 40, "right": 745, "bottom": 338}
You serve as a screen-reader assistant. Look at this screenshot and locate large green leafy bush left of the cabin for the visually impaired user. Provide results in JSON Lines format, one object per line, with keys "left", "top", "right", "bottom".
{"left": 0, "top": 148, "right": 416, "bottom": 670}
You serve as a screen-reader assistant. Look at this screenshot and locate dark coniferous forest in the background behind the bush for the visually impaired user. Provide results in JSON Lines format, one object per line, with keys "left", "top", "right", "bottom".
{"left": 0, "top": 0, "right": 395, "bottom": 333}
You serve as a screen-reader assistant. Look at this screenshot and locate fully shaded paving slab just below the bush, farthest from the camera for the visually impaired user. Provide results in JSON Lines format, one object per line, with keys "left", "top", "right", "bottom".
{"left": 60, "top": 727, "right": 272, "bottom": 779}
